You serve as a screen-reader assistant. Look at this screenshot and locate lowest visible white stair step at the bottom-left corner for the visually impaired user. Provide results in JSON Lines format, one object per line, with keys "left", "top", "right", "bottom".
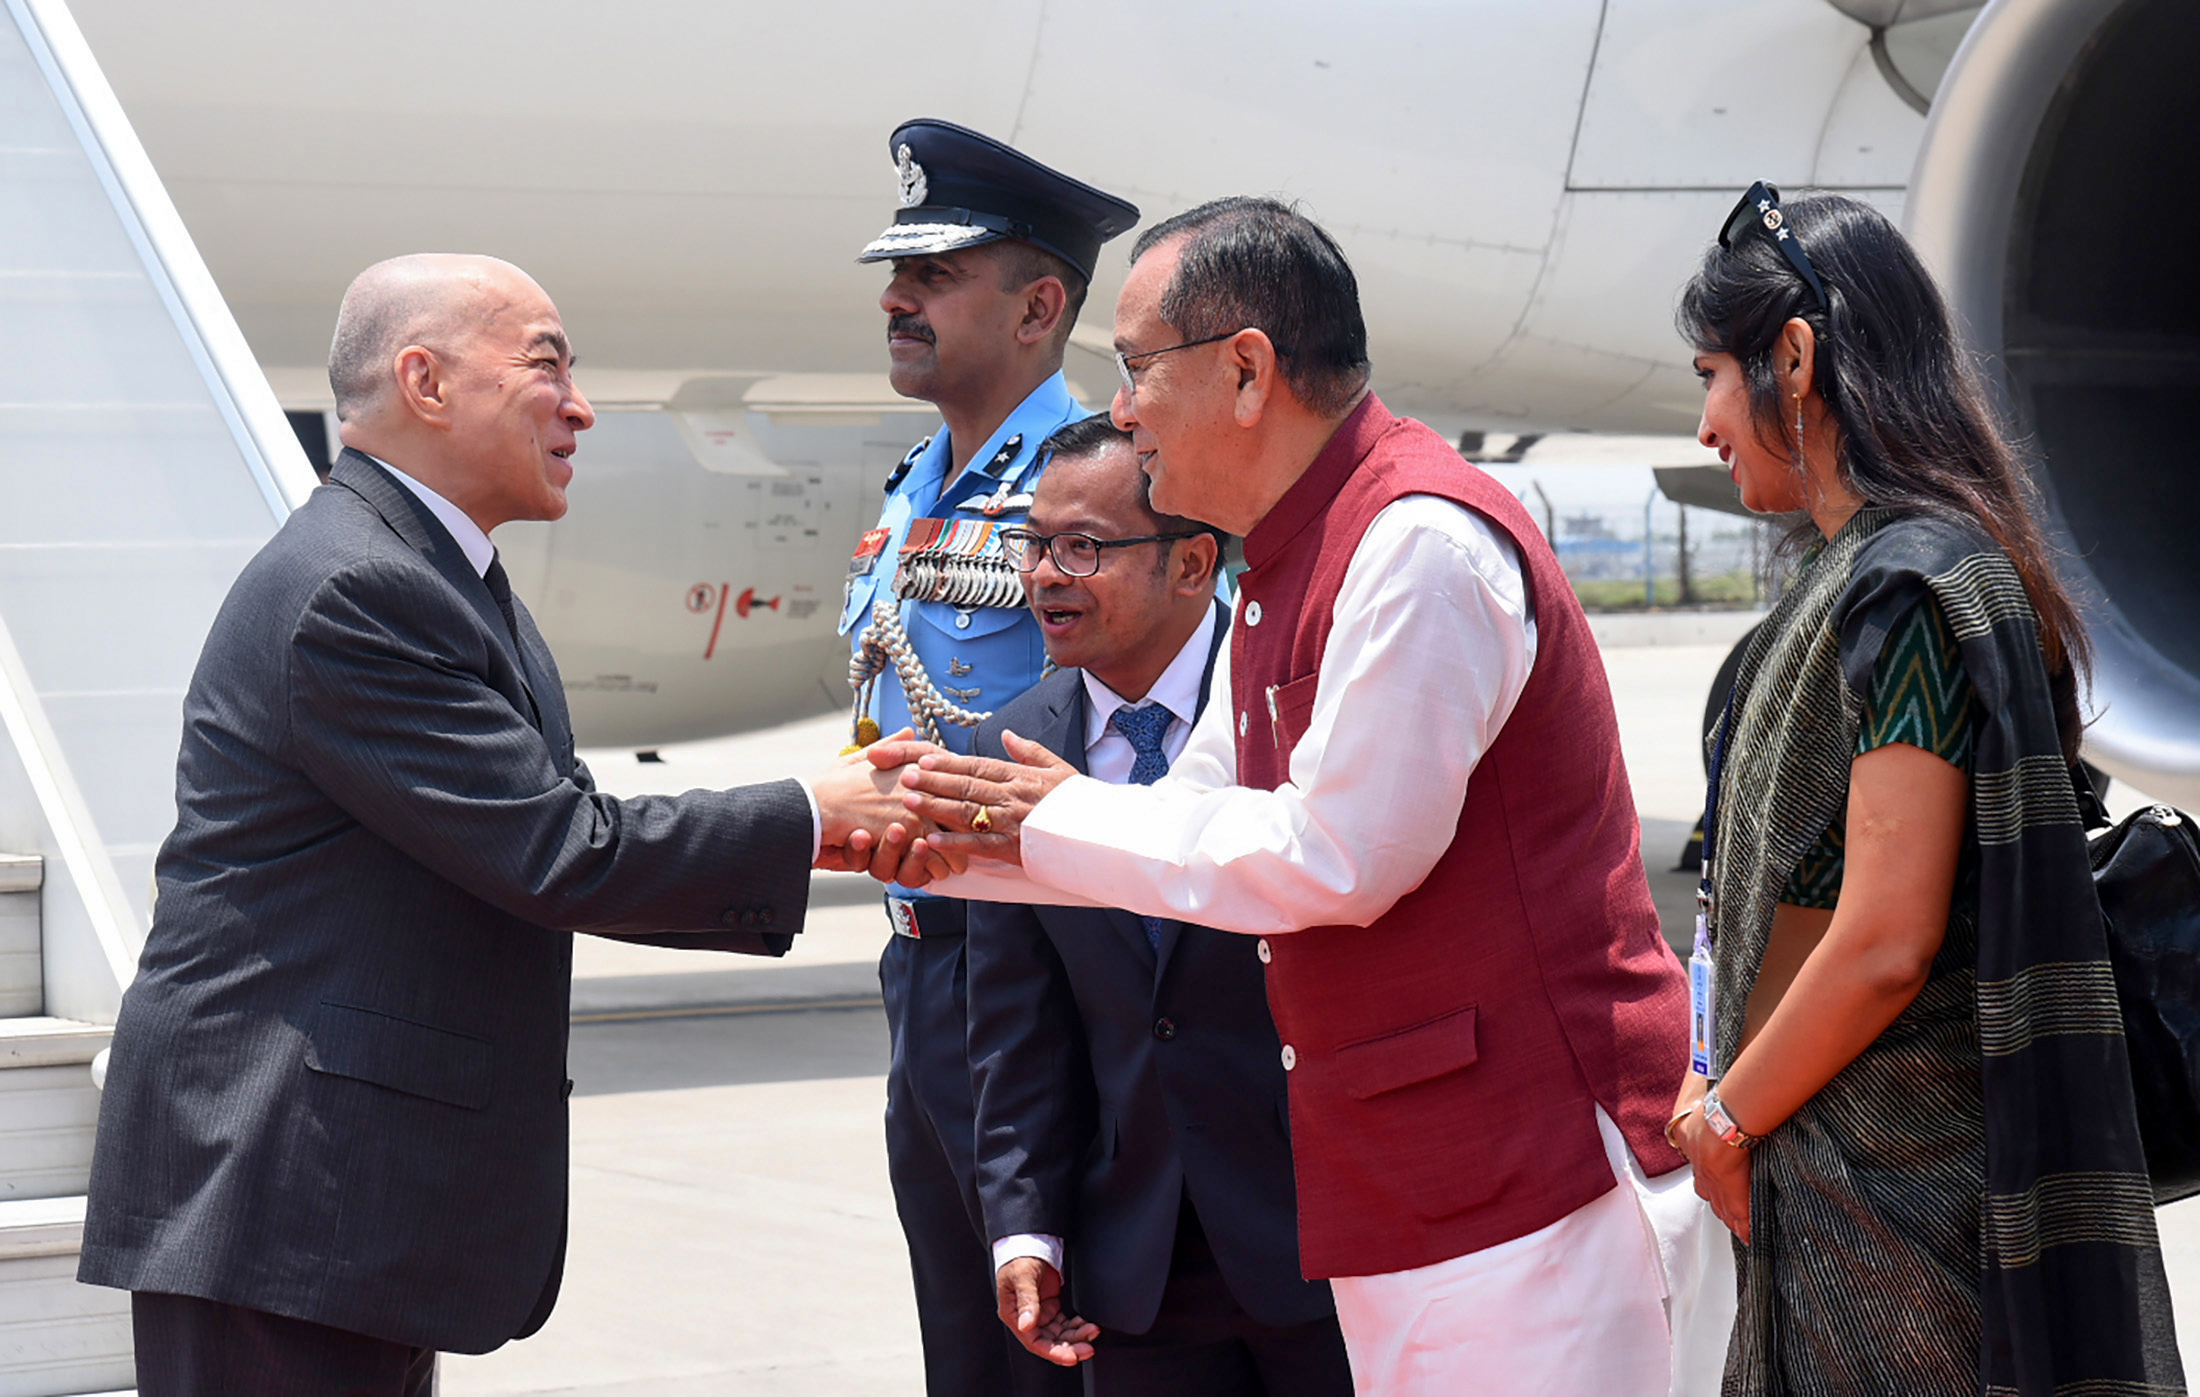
{"left": 0, "top": 1195, "right": 136, "bottom": 1397}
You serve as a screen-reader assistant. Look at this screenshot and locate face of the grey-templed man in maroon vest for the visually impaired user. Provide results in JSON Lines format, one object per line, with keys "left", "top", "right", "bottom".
{"left": 1109, "top": 238, "right": 1258, "bottom": 532}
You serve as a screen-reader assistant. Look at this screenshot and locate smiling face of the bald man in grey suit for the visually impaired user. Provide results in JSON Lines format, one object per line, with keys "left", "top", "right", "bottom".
{"left": 449, "top": 268, "right": 596, "bottom": 530}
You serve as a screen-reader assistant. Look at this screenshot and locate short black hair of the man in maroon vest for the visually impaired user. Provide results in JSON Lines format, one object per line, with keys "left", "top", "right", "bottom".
{"left": 1131, "top": 194, "right": 1368, "bottom": 418}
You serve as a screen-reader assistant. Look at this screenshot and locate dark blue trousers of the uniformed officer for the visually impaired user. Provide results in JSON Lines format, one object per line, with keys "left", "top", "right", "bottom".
{"left": 878, "top": 909, "right": 1082, "bottom": 1397}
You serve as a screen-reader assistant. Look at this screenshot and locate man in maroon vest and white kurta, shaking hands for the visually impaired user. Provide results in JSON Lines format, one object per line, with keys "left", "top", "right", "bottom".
{"left": 876, "top": 198, "right": 1716, "bottom": 1397}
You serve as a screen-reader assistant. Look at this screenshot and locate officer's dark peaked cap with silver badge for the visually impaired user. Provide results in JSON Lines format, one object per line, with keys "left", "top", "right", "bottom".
{"left": 856, "top": 117, "right": 1137, "bottom": 277}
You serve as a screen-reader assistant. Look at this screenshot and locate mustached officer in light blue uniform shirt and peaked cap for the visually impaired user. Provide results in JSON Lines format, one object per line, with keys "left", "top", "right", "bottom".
{"left": 840, "top": 121, "right": 1137, "bottom": 1397}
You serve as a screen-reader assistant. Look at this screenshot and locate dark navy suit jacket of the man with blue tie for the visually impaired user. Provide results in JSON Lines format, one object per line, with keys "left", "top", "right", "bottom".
{"left": 968, "top": 605, "right": 1331, "bottom": 1333}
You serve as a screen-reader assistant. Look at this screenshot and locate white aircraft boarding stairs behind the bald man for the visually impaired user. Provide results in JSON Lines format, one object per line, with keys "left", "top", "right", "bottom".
{"left": 0, "top": 0, "right": 315, "bottom": 1397}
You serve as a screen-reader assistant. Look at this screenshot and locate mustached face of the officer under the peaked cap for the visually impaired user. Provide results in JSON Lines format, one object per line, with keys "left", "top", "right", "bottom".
{"left": 878, "top": 244, "right": 1025, "bottom": 403}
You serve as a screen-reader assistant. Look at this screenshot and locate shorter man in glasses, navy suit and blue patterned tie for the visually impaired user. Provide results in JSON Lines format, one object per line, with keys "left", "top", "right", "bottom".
{"left": 970, "top": 416, "right": 1353, "bottom": 1397}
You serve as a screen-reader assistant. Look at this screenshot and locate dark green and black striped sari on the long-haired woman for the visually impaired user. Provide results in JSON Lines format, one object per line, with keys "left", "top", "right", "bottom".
{"left": 1712, "top": 510, "right": 2185, "bottom": 1397}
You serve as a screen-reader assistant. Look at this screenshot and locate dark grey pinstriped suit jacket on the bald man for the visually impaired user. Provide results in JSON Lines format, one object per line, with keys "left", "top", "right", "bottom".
{"left": 79, "top": 451, "right": 812, "bottom": 1353}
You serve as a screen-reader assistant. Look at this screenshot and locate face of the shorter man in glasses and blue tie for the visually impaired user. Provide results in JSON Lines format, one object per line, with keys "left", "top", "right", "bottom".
{"left": 1023, "top": 444, "right": 1214, "bottom": 700}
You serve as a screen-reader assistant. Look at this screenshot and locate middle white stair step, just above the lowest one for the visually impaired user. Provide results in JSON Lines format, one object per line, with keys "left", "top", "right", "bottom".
{"left": 0, "top": 1019, "right": 114, "bottom": 1205}
